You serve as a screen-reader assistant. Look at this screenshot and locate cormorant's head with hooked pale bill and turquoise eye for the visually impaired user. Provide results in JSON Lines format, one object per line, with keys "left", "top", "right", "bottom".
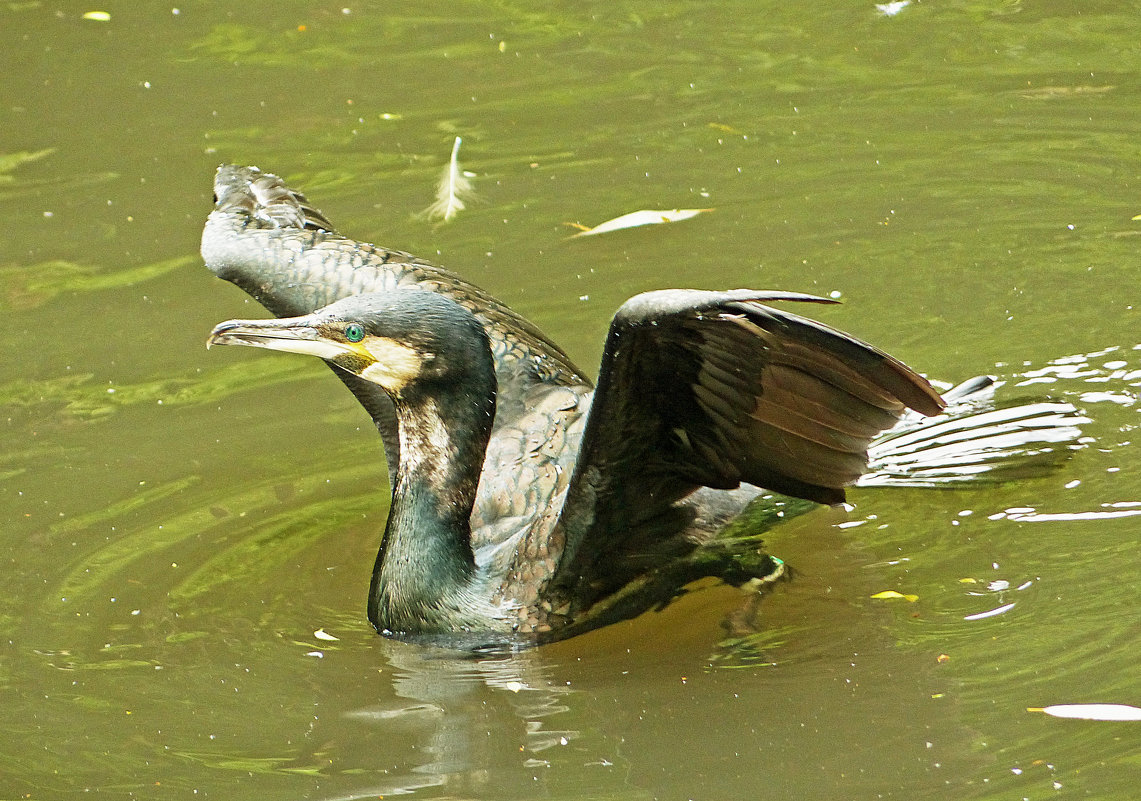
{"left": 207, "top": 290, "right": 494, "bottom": 398}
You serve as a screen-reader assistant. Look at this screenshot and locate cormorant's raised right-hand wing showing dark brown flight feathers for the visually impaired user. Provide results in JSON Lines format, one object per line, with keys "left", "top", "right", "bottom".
{"left": 559, "top": 290, "right": 944, "bottom": 581}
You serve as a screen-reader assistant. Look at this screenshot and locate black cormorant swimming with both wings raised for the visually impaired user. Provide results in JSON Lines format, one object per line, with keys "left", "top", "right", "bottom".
{"left": 202, "top": 165, "right": 1084, "bottom": 642}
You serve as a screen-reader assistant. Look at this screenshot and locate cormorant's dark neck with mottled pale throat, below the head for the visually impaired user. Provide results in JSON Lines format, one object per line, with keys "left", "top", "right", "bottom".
{"left": 369, "top": 385, "right": 495, "bottom": 633}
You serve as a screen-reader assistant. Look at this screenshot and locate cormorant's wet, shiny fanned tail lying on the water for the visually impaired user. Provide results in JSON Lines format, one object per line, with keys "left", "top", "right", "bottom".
{"left": 857, "top": 375, "right": 1090, "bottom": 487}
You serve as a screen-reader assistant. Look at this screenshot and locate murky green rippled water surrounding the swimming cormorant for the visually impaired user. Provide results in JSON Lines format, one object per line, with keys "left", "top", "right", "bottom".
{"left": 0, "top": 0, "right": 1141, "bottom": 801}
